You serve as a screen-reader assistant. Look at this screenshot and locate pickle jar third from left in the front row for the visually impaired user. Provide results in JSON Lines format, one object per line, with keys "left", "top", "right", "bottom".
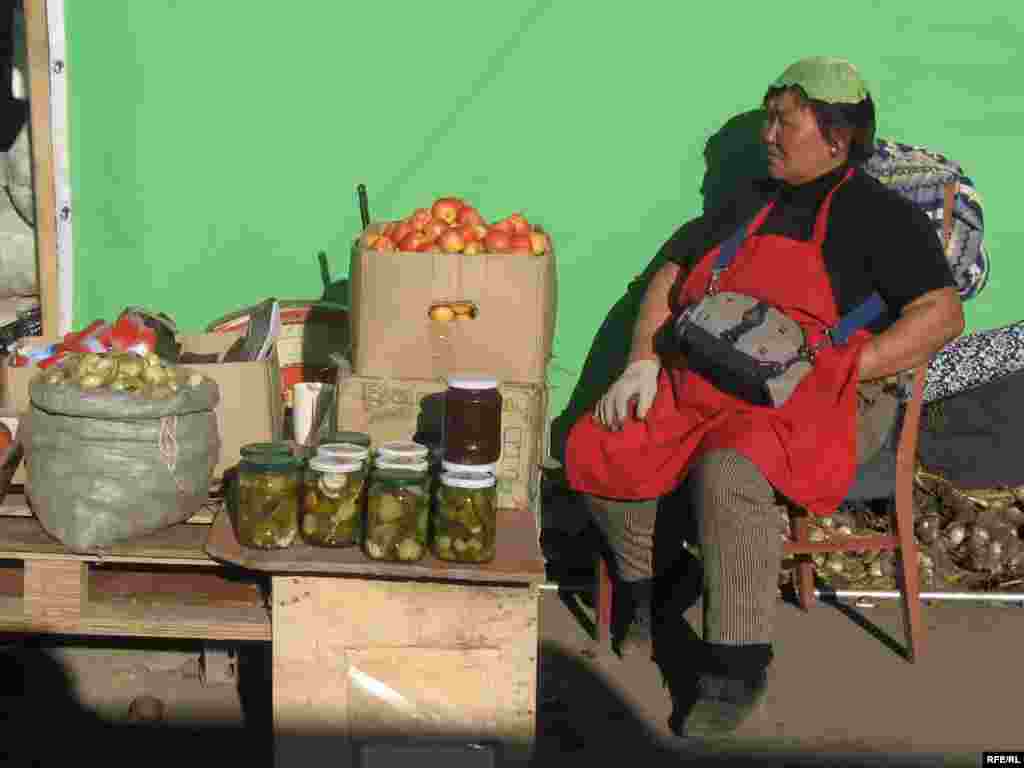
{"left": 364, "top": 456, "right": 430, "bottom": 562}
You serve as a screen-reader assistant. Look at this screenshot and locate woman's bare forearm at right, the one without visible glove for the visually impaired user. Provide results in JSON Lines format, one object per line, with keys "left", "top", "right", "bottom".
{"left": 860, "top": 288, "right": 964, "bottom": 381}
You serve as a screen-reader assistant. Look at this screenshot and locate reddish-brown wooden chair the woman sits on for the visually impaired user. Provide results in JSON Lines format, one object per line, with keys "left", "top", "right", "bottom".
{"left": 594, "top": 366, "right": 928, "bottom": 662}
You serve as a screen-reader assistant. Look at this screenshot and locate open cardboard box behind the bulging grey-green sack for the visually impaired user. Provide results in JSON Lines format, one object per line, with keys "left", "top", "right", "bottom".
{"left": 0, "top": 333, "right": 285, "bottom": 483}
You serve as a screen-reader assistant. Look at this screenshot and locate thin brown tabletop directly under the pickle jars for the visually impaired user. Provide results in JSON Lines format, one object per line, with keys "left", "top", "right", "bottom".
{"left": 204, "top": 509, "right": 545, "bottom": 584}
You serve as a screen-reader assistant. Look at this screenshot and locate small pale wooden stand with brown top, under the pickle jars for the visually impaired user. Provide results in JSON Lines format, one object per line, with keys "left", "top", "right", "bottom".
{"left": 207, "top": 509, "right": 545, "bottom": 768}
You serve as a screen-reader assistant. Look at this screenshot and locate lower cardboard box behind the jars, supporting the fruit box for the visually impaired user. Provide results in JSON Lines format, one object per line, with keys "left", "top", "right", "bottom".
{"left": 338, "top": 376, "right": 548, "bottom": 508}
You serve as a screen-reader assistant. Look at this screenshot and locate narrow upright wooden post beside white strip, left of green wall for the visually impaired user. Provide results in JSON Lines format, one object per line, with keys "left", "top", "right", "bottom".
{"left": 25, "top": 0, "right": 60, "bottom": 336}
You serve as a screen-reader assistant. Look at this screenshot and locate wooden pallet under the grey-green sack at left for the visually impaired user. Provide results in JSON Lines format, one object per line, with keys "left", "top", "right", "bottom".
{"left": 0, "top": 496, "right": 270, "bottom": 641}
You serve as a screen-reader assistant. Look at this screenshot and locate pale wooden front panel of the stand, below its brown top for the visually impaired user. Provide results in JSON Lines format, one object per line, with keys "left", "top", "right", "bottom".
{"left": 271, "top": 575, "right": 538, "bottom": 767}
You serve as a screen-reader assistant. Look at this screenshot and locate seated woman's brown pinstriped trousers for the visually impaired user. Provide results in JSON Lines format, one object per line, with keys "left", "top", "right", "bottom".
{"left": 584, "top": 382, "right": 898, "bottom": 645}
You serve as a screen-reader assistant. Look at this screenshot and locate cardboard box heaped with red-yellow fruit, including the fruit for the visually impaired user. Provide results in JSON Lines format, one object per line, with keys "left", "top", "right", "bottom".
{"left": 349, "top": 197, "right": 557, "bottom": 383}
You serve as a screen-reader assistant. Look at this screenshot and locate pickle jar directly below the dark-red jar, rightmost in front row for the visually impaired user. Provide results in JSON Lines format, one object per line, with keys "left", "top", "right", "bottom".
{"left": 432, "top": 472, "right": 498, "bottom": 562}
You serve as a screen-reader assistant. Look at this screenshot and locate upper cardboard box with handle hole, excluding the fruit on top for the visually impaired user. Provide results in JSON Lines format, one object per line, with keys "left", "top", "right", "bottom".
{"left": 349, "top": 243, "right": 557, "bottom": 384}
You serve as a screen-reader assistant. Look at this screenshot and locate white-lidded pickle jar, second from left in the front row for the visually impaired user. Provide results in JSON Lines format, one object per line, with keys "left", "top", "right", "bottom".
{"left": 301, "top": 454, "right": 367, "bottom": 547}
